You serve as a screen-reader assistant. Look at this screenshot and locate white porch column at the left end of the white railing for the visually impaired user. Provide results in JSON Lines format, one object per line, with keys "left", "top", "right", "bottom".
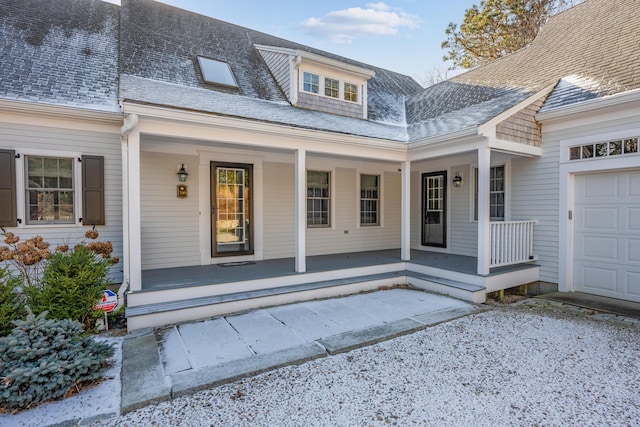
{"left": 478, "top": 147, "right": 491, "bottom": 275}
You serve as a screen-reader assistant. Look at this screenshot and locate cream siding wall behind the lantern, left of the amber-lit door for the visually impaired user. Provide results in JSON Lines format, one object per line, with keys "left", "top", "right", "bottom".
{"left": 140, "top": 151, "right": 200, "bottom": 270}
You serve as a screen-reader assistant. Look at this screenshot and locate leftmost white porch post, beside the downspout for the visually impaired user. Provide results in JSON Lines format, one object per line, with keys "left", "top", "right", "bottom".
{"left": 125, "top": 130, "right": 142, "bottom": 292}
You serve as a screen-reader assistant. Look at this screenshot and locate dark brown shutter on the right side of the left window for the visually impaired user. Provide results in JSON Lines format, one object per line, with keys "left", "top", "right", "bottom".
{"left": 82, "top": 156, "right": 105, "bottom": 225}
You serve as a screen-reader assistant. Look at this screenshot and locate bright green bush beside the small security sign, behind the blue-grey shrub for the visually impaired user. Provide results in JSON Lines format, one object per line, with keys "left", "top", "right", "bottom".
{"left": 25, "top": 245, "right": 112, "bottom": 330}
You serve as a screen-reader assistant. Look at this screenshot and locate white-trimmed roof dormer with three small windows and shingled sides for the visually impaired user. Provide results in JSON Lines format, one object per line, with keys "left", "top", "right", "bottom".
{"left": 256, "top": 45, "right": 375, "bottom": 119}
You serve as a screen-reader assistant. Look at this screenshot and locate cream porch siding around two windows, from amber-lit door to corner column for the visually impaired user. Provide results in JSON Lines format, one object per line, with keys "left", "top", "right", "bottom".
{"left": 263, "top": 159, "right": 401, "bottom": 259}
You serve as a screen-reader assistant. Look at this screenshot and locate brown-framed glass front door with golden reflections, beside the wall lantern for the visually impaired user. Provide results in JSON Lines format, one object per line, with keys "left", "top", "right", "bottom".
{"left": 211, "top": 162, "right": 253, "bottom": 257}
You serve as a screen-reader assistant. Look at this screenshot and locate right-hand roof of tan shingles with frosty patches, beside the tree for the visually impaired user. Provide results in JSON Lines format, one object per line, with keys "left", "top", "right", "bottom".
{"left": 407, "top": 0, "right": 640, "bottom": 139}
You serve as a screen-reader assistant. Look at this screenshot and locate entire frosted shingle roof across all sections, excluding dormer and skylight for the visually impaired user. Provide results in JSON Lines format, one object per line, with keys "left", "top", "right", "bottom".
{"left": 0, "top": 0, "right": 640, "bottom": 141}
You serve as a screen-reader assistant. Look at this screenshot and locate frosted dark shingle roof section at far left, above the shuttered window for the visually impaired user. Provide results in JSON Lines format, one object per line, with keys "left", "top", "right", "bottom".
{"left": 0, "top": 0, "right": 120, "bottom": 112}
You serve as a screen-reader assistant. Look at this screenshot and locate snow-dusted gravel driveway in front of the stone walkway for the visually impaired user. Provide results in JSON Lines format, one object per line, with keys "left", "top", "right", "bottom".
{"left": 92, "top": 305, "right": 640, "bottom": 427}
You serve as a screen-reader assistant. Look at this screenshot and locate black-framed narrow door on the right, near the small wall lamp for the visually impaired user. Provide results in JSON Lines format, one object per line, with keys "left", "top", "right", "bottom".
{"left": 422, "top": 171, "right": 447, "bottom": 248}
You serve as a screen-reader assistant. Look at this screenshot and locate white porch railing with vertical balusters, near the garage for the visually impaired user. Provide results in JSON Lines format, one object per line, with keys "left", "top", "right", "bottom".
{"left": 490, "top": 220, "right": 538, "bottom": 267}
